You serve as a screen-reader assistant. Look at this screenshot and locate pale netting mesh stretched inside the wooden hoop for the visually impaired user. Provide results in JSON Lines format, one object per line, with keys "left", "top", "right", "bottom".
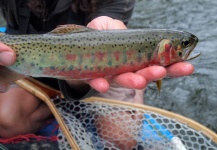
{"left": 53, "top": 99, "right": 217, "bottom": 150}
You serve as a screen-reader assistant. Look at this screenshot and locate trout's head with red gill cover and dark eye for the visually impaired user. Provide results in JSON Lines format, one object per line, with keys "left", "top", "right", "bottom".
{"left": 158, "top": 32, "right": 200, "bottom": 66}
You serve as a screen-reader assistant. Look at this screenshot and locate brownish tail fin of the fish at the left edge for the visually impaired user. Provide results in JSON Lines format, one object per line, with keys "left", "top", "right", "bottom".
{"left": 0, "top": 66, "right": 25, "bottom": 93}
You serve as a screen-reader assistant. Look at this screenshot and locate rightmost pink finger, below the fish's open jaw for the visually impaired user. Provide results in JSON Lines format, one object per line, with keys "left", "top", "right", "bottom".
{"left": 167, "top": 62, "right": 194, "bottom": 77}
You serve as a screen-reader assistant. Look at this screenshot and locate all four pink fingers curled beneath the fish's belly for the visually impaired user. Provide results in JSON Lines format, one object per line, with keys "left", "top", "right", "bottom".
{"left": 88, "top": 62, "right": 194, "bottom": 93}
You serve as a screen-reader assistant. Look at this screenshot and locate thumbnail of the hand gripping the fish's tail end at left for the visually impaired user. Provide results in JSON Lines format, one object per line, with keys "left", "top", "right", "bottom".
{"left": 0, "top": 52, "right": 14, "bottom": 66}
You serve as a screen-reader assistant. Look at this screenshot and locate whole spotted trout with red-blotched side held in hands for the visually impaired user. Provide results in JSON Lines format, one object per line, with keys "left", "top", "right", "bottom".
{"left": 0, "top": 24, "right": 200, "bottom": 91}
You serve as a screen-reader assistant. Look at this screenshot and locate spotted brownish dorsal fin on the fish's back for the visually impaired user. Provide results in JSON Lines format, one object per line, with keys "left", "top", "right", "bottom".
{"left": 49, "top": 24, "right": 93, "bottom": 35}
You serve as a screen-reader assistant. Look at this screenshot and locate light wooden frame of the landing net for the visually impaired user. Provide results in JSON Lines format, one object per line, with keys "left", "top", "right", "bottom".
{"left": 16, "top": 78, "right": 217, "bottom": 150}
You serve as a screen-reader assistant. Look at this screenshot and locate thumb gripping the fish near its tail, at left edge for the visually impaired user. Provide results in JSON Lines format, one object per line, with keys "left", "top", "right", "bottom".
{"left": 0, "top": 43, "right": 16, "bottom": 66}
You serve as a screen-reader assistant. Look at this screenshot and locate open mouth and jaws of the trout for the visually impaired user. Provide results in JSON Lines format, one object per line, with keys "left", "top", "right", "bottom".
{"left": 182, "top": 36, "right": 201, "bottom": 61}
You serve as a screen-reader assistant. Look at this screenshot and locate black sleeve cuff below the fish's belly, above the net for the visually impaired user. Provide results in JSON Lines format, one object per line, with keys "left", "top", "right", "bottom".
{"left": 59, "top": 80, "right": 97, "bottom": 100}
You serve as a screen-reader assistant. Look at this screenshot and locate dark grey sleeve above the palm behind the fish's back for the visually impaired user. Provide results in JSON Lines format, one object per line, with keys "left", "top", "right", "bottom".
{"left": 86, "top": 0, "right": 136, "bottom": 24}
